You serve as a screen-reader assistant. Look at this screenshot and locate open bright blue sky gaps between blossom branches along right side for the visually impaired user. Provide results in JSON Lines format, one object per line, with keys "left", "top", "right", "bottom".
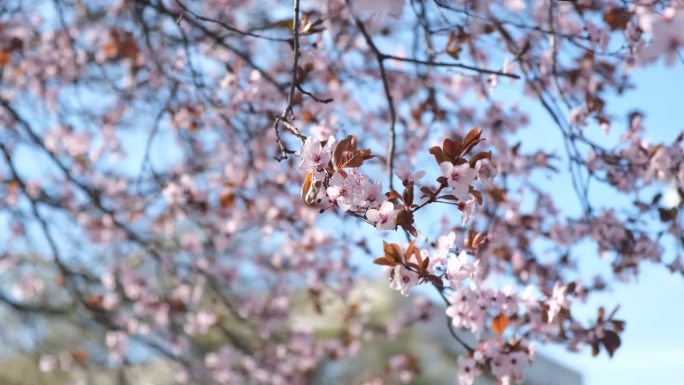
{"left": 504, "top": 64, "right": 684, "bottom": 385}
